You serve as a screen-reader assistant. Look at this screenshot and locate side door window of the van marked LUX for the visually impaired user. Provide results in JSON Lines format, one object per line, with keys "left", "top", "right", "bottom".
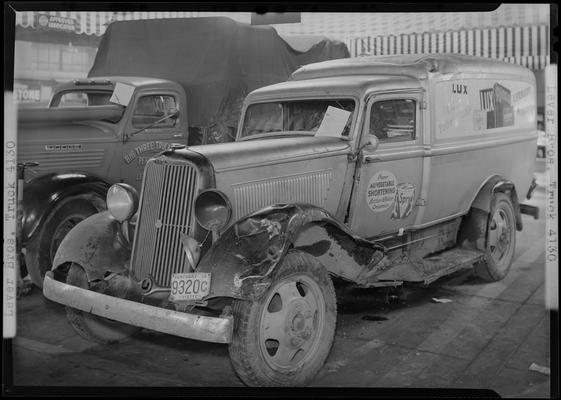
{"left": 370, "top": 99, "right": 416, "bottom": 142}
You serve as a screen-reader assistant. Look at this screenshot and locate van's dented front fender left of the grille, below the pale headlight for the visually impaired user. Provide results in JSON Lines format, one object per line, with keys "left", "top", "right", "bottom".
{"left": 52, "top": 211, "right": 131, "bottom": 281}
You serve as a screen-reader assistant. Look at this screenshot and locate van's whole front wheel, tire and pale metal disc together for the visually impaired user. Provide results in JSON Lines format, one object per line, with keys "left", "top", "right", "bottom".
{"left": 229, "top": 251, "right": 337, "bottom": 386}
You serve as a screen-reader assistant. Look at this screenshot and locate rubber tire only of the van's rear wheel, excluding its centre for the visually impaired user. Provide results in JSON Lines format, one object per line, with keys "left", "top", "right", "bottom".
{"left": 474, "top": 193, "right": 516, "bottom": 282}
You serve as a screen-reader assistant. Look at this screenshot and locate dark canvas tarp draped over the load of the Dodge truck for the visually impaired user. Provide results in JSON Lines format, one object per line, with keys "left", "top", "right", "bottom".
{"left": 88, "top": 17, "right": 349, "bottom": 127}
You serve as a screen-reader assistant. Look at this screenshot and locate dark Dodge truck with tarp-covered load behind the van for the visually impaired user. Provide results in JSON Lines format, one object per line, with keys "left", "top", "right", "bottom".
{"left": 18, "top": 17, "right": 349, "bottom": 287}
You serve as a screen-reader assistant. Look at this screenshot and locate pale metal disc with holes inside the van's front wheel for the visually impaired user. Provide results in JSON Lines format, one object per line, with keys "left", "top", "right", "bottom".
{"left": 259, "top": 276, "right": 325, "bottom": 369}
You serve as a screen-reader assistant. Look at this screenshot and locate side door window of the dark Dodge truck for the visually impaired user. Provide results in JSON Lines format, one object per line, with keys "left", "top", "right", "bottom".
{"left": 132, "top": 95, "right": 177, "bottom": 128}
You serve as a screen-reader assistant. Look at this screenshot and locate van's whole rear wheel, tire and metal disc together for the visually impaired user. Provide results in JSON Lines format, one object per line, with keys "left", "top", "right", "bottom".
{"left": 474, "top": 193, "right": 516, "bottom": 282}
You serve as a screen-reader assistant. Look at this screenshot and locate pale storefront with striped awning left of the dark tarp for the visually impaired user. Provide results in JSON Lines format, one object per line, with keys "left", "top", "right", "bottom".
{"left": 14, "top": 11, "right": 214, "bottom": 106}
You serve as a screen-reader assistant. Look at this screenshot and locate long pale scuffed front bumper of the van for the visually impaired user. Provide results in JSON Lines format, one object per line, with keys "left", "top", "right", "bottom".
{"left": 43, "top": 271, "right": 234, "bottom": 343}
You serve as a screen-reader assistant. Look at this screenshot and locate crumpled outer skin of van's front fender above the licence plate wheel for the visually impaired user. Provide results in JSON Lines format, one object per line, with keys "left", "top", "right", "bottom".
{"left": 196, "top": 204, "right": 381, "bottom": 300}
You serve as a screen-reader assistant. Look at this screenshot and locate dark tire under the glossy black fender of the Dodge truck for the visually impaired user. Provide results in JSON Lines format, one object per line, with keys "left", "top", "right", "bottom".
{"left": 25, "top": 199, "right": 97, "bottom": 289}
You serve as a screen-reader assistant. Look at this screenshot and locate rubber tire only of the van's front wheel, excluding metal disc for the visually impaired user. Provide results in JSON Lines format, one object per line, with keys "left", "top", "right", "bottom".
{"left": 229, "top": 250, "right": 337, "bottom": 386}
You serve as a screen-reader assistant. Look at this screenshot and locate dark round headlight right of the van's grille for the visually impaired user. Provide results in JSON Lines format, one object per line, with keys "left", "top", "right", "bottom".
{"left": 195, "top": 189, "right": 232, "bottom": 231}
